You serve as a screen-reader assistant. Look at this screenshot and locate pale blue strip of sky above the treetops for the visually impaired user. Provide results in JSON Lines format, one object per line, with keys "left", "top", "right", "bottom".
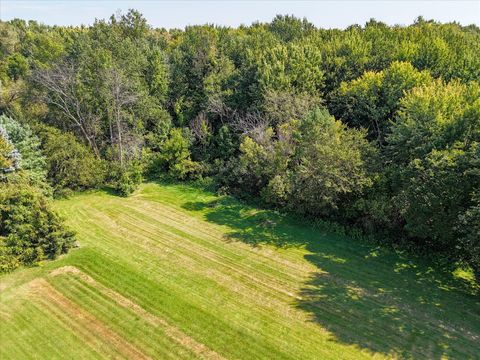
{"left": 0, "top": 0, "right": 480, "bottom": 29}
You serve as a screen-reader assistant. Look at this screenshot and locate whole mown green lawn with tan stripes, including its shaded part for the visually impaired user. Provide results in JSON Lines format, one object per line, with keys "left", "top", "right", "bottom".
{"left": 0, "top": 183, "right": 480, "bottom": 360}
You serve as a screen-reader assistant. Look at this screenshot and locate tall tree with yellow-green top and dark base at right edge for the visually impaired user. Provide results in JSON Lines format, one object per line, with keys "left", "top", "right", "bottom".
{"left": 386, "top": 81, "right": 480, "bottom": 258}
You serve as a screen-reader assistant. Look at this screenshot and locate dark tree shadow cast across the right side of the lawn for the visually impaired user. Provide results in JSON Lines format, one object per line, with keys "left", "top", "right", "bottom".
{"left": 184, "top": 197, "right": 480, "bottom": 359}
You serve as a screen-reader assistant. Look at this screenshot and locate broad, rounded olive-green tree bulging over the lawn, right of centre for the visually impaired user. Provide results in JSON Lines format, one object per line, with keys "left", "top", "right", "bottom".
{"left": 227, "top": 109, "right": 374, "bottom": 215}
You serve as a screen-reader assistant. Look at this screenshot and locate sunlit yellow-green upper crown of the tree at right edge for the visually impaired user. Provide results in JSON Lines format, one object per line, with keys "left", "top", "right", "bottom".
{"left": 387, "top": 81, "right": 480, "bottom": 165}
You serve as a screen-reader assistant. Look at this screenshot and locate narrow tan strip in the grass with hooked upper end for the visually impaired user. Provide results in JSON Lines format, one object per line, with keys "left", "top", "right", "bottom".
{"left": 50, "top": 266, "right": 224, "bottom": 360}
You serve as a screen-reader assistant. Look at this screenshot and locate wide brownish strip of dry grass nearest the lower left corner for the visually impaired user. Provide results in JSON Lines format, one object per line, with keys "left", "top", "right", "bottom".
{"left": 29, "top": 278, "right": 151, "bottom": 360}
